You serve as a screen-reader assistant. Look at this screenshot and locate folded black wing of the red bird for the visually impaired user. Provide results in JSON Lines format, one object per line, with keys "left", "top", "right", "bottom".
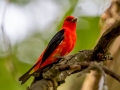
{"left": 41, "top": 29, "right": 64, "bottom": 65}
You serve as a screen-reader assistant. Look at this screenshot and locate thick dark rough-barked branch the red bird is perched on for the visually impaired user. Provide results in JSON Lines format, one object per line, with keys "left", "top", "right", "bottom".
{"left": 28, "top": 20, "right": 120, "bottom": 90}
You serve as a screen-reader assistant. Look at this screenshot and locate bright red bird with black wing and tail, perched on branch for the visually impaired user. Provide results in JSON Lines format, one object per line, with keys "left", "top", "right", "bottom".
{"left": 19, "top": 16, "right": 77, "bottom": 84}
